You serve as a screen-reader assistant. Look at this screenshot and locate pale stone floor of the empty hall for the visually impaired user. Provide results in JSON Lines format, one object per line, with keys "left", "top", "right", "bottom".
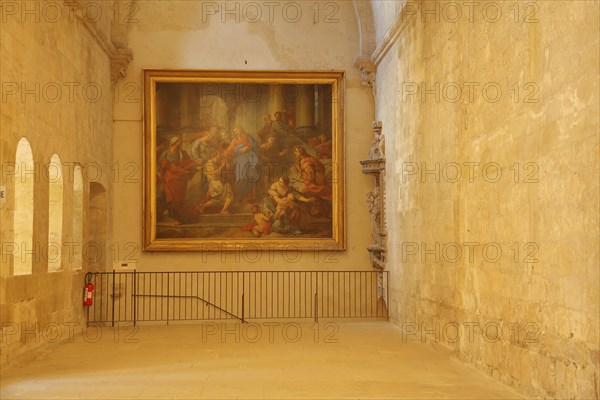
{"left": 0, "top": 321, "right": 521, "bottom": 400}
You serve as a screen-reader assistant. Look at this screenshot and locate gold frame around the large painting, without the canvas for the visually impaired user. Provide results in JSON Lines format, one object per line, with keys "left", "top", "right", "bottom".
{"left": 142, "top": 69, "right": 346, "bottom": 251}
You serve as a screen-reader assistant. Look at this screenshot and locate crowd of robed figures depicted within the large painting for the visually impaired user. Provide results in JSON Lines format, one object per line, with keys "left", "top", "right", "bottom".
{"left": 157, "top": 113, "right": 332, "bottom": 237}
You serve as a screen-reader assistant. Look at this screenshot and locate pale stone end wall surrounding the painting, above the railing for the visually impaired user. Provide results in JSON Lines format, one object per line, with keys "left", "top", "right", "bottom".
{"left": 112, "top": 1, "right": 373, "bottom": 271}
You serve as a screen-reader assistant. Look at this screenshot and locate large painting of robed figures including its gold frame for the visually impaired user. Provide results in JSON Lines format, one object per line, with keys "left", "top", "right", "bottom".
{"left": 143, "top": 69, "right": 346, "bottom": 251}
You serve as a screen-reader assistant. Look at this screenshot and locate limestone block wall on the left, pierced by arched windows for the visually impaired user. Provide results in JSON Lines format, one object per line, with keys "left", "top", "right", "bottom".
{"left": 0, "top": 2, "right": 112, "bottom": 363}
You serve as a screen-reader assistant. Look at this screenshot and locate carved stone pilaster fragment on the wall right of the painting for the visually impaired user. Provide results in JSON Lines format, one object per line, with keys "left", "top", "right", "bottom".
{"left": 360, "top": 121, "right": 387, "bottom": 270}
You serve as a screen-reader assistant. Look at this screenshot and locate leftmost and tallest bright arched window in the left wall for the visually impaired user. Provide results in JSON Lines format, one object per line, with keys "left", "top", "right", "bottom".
{"left": 13, "top": 137, "right": 35, "bottom": 275}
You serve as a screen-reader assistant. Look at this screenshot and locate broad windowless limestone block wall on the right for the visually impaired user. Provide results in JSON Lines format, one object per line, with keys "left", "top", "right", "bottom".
{"left": 373, "top": 1, "right": 600, "bottom": 398}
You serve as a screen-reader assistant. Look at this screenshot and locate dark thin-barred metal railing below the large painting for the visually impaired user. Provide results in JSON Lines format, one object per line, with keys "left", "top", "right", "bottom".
{"left": 85, "top": 271, "right": 389, "bottom": 325}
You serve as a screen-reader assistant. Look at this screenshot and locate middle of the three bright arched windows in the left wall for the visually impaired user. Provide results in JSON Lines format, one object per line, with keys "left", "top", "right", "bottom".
{"left": 47, "top": 154, "right": 63, "bottom": 272}
